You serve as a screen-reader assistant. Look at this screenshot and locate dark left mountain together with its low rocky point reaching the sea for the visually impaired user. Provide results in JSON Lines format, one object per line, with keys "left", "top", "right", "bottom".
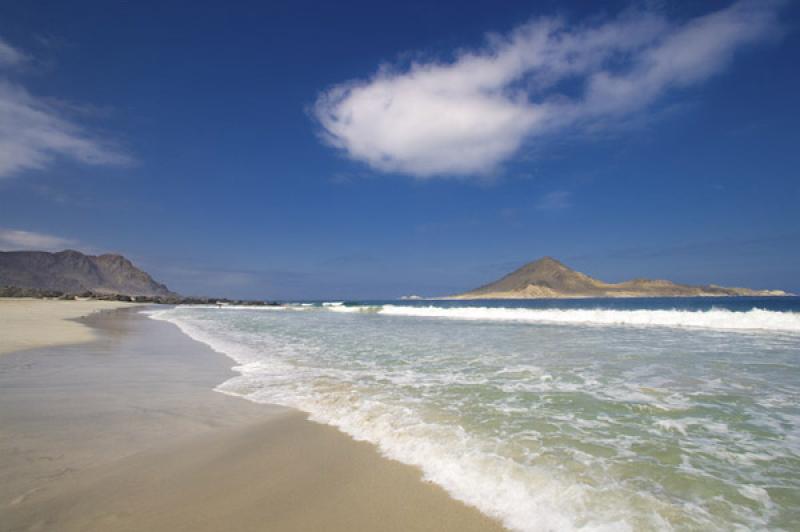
{"left": 0, "top": 249, "right": 272, "bottom": 305}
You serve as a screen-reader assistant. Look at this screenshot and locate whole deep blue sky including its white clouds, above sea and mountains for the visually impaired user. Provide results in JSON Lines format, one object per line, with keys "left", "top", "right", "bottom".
{"left": 0, "top": 0, "right": 800, "bottom": 299}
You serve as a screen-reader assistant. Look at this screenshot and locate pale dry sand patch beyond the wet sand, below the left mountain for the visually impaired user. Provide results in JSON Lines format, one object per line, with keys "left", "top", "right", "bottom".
{"left": 0, "top": 298, "right": 134, "bottom": 355}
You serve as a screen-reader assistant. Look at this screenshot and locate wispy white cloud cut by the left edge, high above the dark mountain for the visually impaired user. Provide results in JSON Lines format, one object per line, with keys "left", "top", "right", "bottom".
{"left": 0, "top": 39, "right": 130, "bottom": 179}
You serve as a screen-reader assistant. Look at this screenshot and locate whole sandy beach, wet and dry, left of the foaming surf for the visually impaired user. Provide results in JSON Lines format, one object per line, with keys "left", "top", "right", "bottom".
{"left": 0, "top": 301, "right": 501, "bottom": 531}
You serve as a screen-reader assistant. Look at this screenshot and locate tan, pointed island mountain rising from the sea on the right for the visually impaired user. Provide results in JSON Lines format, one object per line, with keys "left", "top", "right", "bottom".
{"left": 452, "top": 257, "right": 788, "bottom": 299}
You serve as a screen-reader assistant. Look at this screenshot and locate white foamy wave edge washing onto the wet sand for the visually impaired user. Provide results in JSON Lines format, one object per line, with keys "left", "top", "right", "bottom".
{"left": 146, "top": 306, "right": 648, "bottom": 532}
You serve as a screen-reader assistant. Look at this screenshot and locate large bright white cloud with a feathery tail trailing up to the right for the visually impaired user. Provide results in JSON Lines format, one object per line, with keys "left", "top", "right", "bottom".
{"left": 313, "top": 0, "right": 780, "bottom": 178}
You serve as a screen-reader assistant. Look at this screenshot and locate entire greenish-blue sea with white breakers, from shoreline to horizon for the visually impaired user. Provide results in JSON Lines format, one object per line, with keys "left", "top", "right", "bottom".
{"left": 150, "top": 297, "right": 800, "bottom": 531}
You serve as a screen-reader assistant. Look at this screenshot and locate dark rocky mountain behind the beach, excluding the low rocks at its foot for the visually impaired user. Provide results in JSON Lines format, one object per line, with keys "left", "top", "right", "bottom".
{"left": 0, "top": 250, "right": 176, "bottom": 296}
